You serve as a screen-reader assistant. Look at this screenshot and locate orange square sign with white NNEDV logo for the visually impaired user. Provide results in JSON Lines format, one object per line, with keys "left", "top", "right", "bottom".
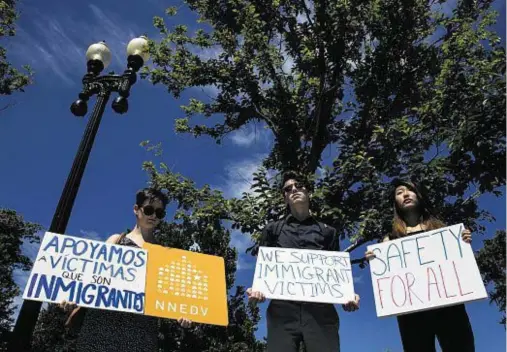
{"left": 144, "top": 243, "right": 229, "bottom": 326}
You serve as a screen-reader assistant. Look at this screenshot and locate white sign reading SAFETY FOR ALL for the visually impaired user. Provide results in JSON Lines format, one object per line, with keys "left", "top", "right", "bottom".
{"left": 368, "top": 224, "right": 487, "bottom": 317}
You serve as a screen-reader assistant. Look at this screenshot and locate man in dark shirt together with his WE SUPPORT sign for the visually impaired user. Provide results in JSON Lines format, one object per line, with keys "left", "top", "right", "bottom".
{"left": 247, "top": 172, "right": 359, "bottom": 352}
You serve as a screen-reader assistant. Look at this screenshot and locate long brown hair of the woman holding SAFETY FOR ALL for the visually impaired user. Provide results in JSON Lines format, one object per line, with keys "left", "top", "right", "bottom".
{"left": 389, "top": 179, "right": 446, "bottom": 239}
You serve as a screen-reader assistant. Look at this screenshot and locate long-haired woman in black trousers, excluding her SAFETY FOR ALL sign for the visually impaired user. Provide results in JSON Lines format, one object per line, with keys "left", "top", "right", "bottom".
{"left": 365, "top": 179, "right": 475, "bottom": 352}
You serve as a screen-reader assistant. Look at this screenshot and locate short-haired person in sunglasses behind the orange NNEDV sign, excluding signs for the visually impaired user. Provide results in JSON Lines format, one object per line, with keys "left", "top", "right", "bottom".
{"left": 63, "top": 189, "right": 191, "bottom": 352}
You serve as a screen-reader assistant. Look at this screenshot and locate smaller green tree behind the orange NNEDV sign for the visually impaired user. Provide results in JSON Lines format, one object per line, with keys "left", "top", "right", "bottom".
{"left": 144, "top": 162, "right": 264, "bottom": 352}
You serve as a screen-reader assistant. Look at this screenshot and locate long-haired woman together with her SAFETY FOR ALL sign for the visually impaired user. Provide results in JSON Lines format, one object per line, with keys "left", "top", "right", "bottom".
{"left": 366, "top": 179, "right": 480, "bottom": 352}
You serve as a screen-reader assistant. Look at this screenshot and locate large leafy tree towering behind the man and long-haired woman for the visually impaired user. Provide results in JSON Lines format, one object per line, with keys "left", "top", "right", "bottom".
{"left": 144, "top": 0, "right": 505, "bottom": 256}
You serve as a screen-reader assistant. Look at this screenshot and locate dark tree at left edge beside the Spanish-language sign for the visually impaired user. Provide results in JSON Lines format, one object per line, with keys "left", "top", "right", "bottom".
{"left": 0, "top": 209, "right": 41, "bottom": 351}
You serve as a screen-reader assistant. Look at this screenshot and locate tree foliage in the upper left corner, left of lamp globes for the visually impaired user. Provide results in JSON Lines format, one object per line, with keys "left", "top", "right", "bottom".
{"left": 0, "top": 0, "right": 32, "bottom": 95}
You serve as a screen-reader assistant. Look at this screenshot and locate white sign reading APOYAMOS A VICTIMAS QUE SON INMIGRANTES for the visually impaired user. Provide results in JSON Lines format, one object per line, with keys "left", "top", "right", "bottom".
{"left": 23, "top": 232, "right": 147, "bottom": 314}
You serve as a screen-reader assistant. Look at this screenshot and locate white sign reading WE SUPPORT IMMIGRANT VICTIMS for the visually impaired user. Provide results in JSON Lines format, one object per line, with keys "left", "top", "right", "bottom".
{"left": 252, "top": 247, "right": 354, "bottom": 304}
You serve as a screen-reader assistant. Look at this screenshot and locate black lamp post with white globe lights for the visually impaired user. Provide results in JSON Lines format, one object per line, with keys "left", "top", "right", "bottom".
{"left": 8, "top": 37, "right": 149, "bottom": 352}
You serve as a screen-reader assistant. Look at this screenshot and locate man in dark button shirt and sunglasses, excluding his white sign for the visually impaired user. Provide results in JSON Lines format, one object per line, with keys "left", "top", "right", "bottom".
{"left": 246, "top": 172, "right": 359, "bottom": 352}
